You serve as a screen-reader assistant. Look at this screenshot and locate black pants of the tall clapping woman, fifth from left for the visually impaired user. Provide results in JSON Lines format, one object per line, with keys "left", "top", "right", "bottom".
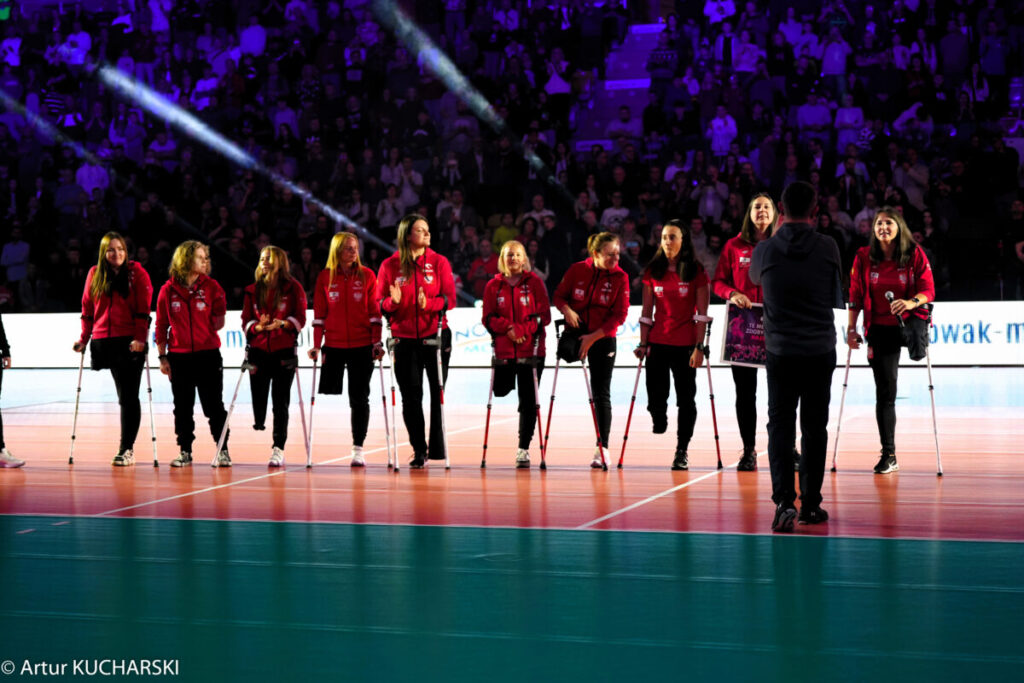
{"left": 394, "top": 330, "right": 452, "bottom": 460}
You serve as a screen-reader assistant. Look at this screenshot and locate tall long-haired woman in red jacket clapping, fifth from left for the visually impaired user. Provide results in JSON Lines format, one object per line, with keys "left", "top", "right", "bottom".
{"left": 374, "top": 213, "right": 456, "bottom": 469}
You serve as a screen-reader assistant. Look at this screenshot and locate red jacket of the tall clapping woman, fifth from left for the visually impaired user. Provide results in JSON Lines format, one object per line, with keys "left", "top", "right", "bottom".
{"left": 374, "top": 249, "right": 456, "bottom": 339}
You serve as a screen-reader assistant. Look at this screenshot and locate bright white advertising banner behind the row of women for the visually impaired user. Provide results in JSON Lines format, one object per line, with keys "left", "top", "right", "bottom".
{"left": 3, "top": 301, "right": 1024, "bottom": 368}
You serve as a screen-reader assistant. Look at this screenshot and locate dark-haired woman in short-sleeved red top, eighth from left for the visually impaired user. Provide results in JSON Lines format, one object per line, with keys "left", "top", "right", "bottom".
{"left": 635, "top": 220, "right": 710, "bottom": 470}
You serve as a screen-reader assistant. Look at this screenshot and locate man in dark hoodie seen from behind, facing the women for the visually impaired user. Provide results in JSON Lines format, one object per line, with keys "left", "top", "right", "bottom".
{"left": 750, "top": 182, "right": 843, "bottom": 532}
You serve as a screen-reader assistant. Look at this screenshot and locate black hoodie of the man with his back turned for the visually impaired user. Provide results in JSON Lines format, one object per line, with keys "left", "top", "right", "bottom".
{"left": 750, "top": 223, "right": 844, "bottom": 355}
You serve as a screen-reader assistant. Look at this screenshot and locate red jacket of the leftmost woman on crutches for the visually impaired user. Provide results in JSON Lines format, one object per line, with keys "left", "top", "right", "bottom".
{"left": 79, "top": 261, "right": 153, "bottom": 344}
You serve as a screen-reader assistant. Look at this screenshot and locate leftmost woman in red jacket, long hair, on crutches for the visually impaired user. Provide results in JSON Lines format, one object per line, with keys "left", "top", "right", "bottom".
{"left": 73, "top": 232, "right": 153, "bottom": 467}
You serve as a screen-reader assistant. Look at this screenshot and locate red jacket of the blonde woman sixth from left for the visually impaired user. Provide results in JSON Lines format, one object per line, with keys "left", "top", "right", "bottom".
{"left": 483, "top": 272, "right": 551, "bottom": 360}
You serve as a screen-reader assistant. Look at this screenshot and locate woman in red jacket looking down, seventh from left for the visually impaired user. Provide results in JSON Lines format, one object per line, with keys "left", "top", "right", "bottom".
{"left": 553, "top": 232, "right": 630, "bottom": 468}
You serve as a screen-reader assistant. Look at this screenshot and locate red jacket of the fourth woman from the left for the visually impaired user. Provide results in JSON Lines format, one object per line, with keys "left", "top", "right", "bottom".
{"left": 313, "top": 266, "right": 381, "bottom": 348}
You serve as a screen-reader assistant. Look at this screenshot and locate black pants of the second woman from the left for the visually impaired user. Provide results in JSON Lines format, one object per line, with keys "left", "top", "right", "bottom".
{"left": 167, "top": 349, "right": 227, "bottom": 452}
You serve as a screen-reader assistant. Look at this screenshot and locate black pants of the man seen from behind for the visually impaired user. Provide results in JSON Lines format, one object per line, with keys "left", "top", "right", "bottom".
{"left": 766, "top": 349, "right": 836, "bottom": 509}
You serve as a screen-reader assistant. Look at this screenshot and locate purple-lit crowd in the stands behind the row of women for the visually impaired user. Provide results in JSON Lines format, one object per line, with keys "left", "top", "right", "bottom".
{"left": 0, "top": 0, "right": 1024, "bottom": 311}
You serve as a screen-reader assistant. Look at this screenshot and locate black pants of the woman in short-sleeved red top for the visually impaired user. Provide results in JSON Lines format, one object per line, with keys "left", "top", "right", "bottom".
{"left": 644, "top": 344, "right": 697, "bottom": 451}
